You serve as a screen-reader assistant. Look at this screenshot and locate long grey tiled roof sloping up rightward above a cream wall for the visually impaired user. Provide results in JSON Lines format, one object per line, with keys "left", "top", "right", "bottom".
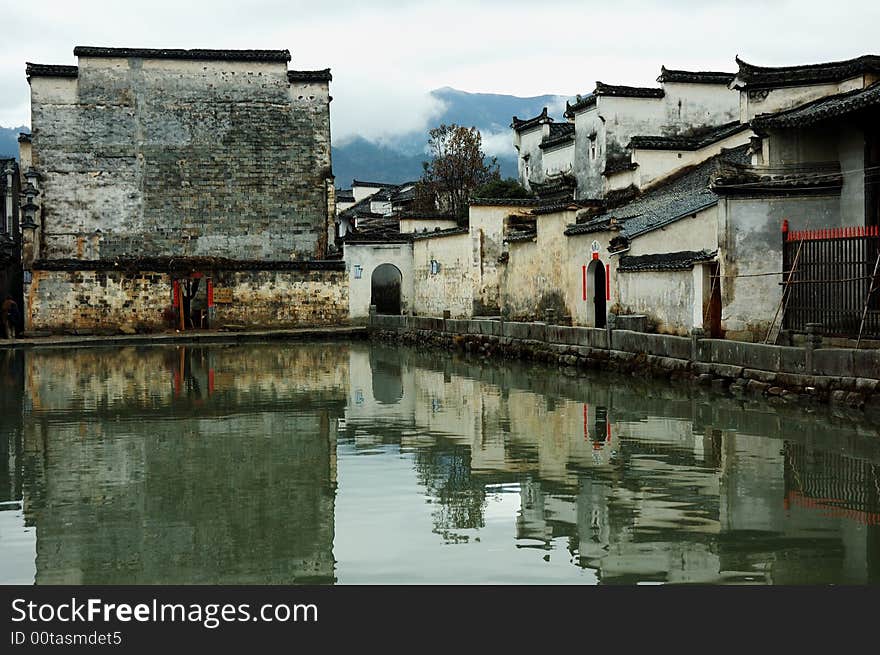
{"left": 565, "top": 146, "right": 748, "bottom": 239}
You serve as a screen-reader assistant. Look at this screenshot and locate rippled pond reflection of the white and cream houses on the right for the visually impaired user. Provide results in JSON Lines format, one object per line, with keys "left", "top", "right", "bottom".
{"left": 345, "top": 349, "right": 880, "bottom": 583}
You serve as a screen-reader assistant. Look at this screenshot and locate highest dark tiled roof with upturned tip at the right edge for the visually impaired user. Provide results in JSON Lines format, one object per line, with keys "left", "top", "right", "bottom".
{"left": 734, "top": 55, "right": 880, "bottom": 89}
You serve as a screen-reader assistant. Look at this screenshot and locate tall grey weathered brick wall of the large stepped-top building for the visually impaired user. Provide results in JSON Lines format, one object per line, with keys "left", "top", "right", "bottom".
{"left": 31, "top": 57, "right": 330, "bottom": 260}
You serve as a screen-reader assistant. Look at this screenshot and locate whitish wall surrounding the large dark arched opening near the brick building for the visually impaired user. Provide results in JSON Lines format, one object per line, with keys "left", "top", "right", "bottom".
{"left": 343, "top": 243, "right": 413, "bottom": 321}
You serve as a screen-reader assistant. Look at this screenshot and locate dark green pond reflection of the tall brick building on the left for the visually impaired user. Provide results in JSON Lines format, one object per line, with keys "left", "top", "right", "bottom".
{"left": 14, "top": 345, "right": 348, "bottom": 584}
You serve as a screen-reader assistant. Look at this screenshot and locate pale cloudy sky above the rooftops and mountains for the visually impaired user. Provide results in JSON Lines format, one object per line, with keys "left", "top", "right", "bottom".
{"left": 0, "top": 0, "right": 880, "bottom": 140}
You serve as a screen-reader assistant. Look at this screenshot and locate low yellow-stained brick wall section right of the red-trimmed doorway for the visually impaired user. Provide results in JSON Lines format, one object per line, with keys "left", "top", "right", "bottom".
{"left": 214, "top": 271, "right": 348, "bottom": 327}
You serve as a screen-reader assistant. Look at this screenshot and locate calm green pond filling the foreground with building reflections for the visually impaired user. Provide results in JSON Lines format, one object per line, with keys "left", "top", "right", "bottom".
{"left": 0, "top": 343, "right": 880, "bottom": 584}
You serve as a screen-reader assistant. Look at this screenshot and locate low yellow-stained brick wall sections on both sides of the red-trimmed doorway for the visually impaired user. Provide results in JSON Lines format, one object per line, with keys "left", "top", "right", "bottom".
{"left": 26, "top": 270, "right": 349, "bottom": 333}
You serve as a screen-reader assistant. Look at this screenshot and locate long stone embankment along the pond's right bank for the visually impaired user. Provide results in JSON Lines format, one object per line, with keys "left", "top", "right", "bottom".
{"left": 369, "top": 315, "right": 880, "bottom": 412}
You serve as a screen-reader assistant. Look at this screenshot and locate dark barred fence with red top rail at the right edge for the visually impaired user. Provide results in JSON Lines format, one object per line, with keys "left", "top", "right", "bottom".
{"left": 782, "top": 226, "right": 880, "bottom": 338}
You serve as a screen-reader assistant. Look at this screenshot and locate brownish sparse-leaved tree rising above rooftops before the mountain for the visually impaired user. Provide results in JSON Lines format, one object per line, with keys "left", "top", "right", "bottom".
{"left": 416, "top": 123, "right": 500, "bottom": 218}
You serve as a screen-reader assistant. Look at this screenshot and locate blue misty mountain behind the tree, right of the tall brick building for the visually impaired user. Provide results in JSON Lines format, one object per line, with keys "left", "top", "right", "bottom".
{"left": 333, "top": 87, "right": 566, "bottom": 188}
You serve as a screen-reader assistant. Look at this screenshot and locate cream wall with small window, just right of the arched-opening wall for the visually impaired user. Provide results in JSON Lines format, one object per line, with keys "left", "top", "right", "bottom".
{"left": 412, "top": 234, "right": 473, "bottom": 318}
